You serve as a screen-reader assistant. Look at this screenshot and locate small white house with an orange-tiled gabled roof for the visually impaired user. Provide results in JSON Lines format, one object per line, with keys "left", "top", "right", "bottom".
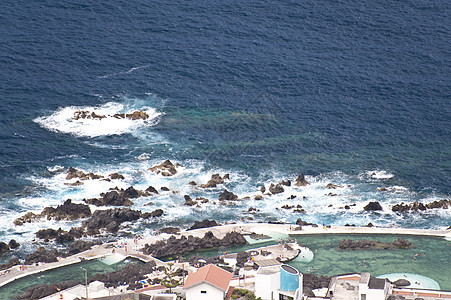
{"left": 184, "top": 264, "right": 232, "bottom": 300}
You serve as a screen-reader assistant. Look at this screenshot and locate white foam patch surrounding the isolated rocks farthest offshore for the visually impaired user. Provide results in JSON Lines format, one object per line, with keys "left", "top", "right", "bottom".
{"left": 34, "top": 102, "right": 162, "bottom": 137}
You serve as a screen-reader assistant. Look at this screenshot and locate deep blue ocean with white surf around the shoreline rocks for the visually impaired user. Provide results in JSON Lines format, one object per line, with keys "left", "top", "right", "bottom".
{"left": 0, "top": 0, "right": 451, "bottom": 255}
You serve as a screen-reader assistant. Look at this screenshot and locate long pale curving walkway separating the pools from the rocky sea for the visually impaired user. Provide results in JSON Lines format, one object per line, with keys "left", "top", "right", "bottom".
{"left": 0, "top": 223, "right": 451, "bottom": 287}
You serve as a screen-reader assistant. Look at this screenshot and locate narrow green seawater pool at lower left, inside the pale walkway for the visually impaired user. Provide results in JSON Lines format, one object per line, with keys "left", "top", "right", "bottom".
{"left": 0, "top": 259, "right": 136, "bottom": 300}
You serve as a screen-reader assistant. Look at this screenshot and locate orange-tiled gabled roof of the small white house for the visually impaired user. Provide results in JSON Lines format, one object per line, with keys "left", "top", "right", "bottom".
{"left": 184, "top": 264, "right": 232, "bottom": 291}
